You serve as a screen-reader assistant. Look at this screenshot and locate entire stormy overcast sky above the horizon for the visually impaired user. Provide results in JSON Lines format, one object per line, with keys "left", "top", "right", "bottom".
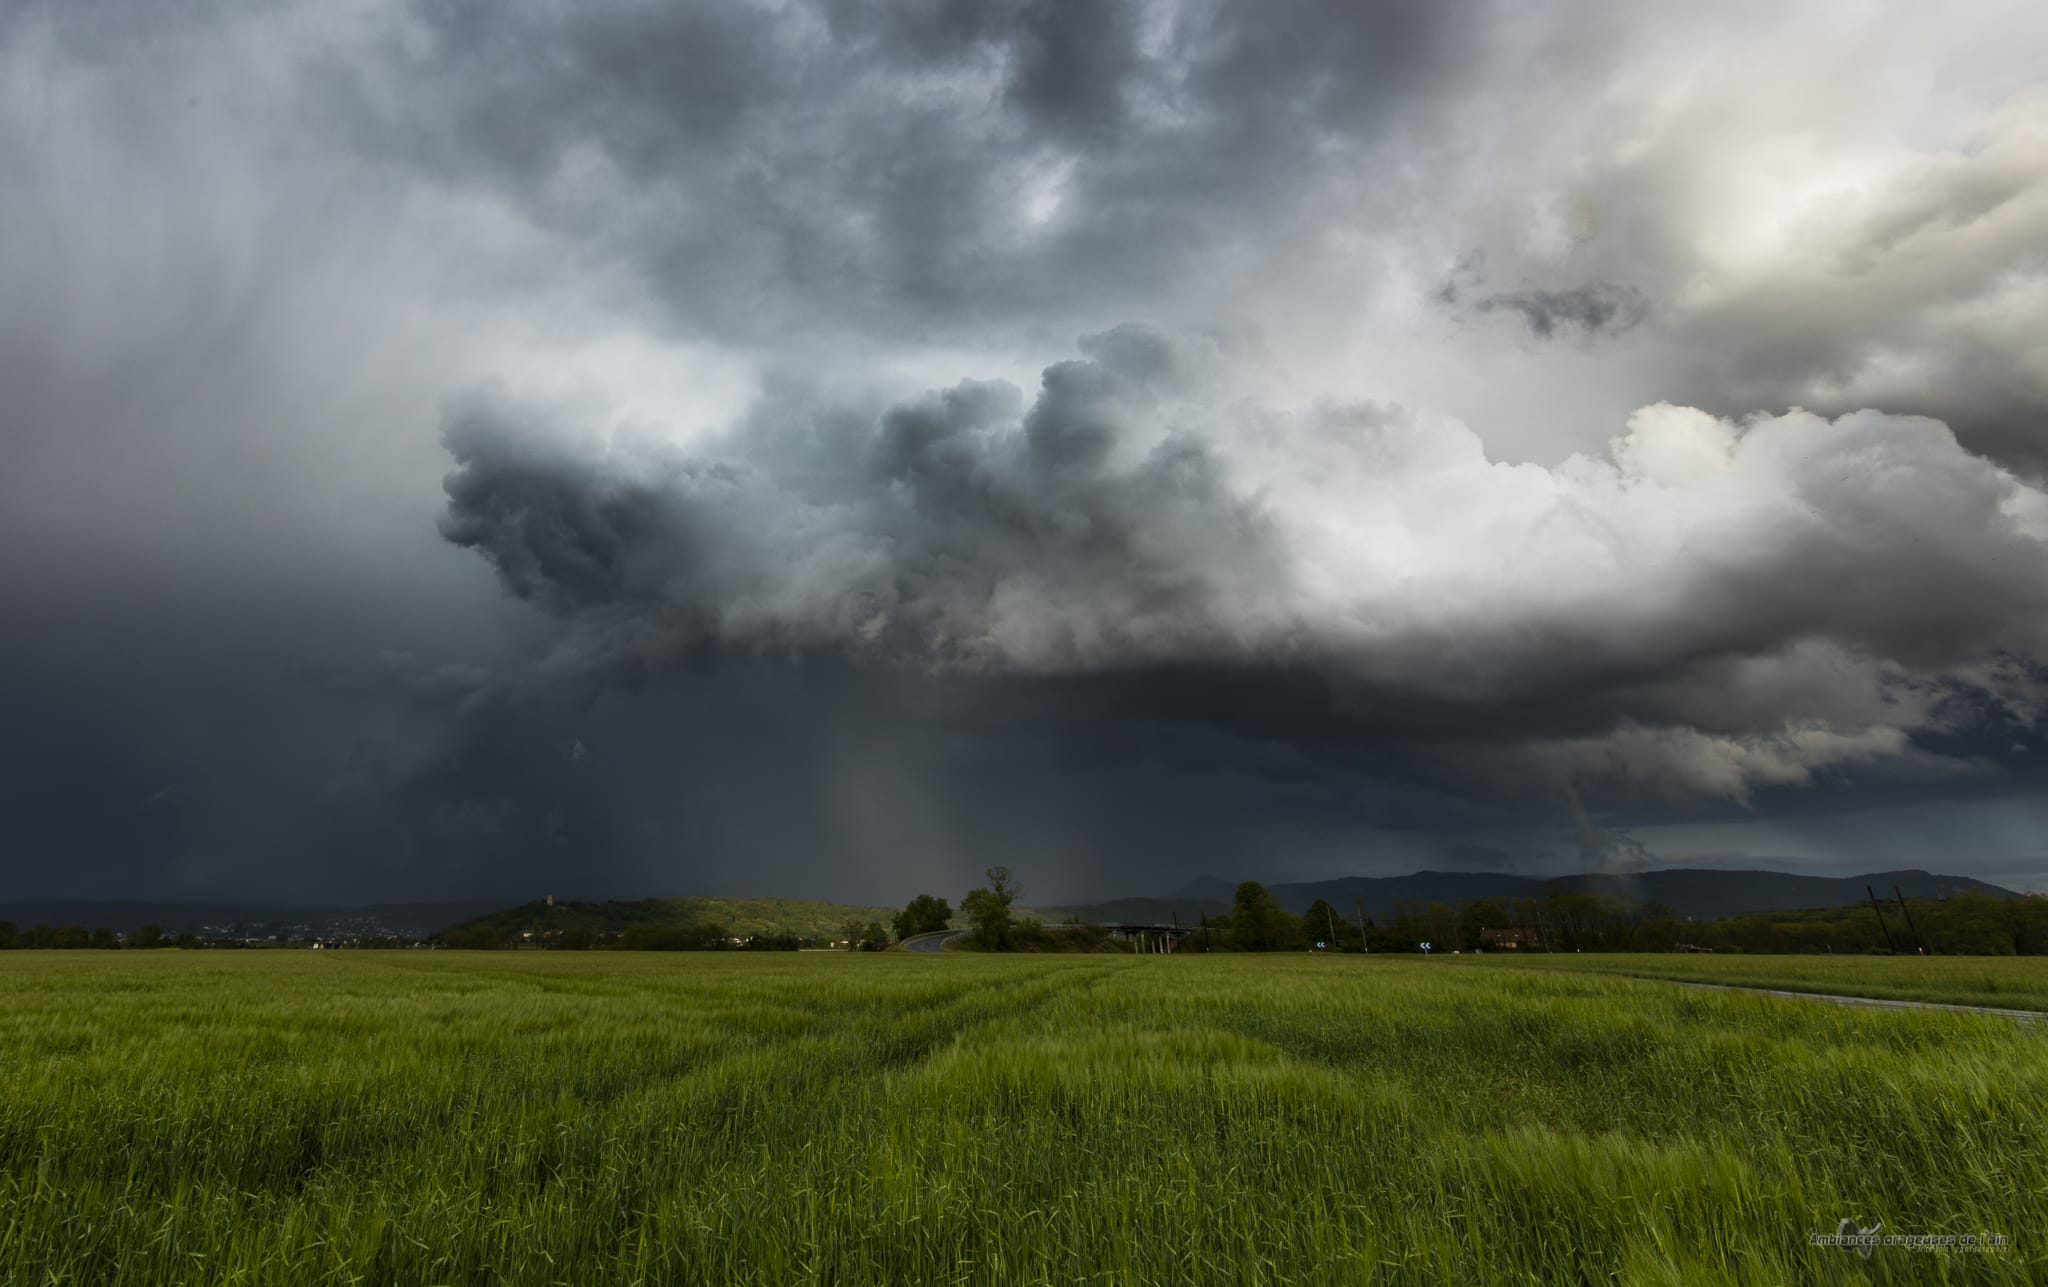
{"left": 0, "top": 0, "right": 2048, "bottom": 902}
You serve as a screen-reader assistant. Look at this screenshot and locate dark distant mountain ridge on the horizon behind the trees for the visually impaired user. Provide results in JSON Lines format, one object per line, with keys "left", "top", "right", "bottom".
{"left": 1155, "top": 867, "right": 2021, "bottom": 918}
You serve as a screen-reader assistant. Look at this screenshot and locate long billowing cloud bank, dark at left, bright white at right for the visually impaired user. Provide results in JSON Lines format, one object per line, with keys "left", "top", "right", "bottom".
{"left": 444, "top": 328, "right": 2048, "bottom": 815}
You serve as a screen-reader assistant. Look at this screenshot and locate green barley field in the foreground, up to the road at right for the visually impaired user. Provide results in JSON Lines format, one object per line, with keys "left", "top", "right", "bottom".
{"left": 0, "top": 951, "right": 2048, "bottom": 1287}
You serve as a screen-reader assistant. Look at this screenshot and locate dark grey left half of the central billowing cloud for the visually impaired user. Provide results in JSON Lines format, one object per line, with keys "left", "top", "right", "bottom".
{"left": 442, "top": 328, "right": 1282, "bottom": 680}
